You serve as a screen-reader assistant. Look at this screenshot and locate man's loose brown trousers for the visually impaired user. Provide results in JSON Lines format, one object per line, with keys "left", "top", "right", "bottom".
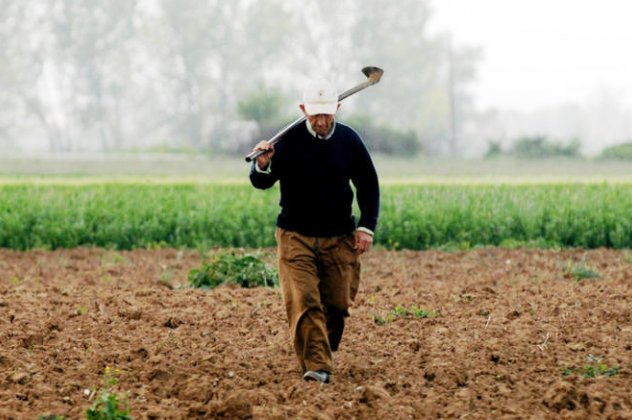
{"left": 276, "top": 228, "right": 360, "bottom": 373}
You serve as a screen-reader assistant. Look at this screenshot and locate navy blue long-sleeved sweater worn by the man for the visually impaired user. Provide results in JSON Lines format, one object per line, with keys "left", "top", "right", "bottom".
{"left": 250, "top": 122, "right": 380, "bottom": 237}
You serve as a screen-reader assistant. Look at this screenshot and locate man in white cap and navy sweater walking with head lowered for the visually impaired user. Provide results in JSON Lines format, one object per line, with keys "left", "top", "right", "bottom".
{"left": 250, "top": 79, "right": 380, "bottom": 383}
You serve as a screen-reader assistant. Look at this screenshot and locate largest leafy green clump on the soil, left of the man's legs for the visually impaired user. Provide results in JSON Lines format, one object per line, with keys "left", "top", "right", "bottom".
{"left": 189, "top": 252, "right": 279, "bottom": 289}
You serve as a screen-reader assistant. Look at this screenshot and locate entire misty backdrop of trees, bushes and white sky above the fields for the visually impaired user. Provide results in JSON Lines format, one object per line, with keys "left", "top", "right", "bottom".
{"left": 0, "top": 0, "right": 632, "bottom": 162}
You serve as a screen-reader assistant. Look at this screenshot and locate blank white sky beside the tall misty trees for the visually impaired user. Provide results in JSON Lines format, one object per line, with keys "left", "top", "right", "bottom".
{"left": 432, "top": 0, "right": 632, "bottom": 111}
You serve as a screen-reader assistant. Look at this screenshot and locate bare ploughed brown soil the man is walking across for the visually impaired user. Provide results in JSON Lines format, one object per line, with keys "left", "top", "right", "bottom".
{"left": 0, "top": 249, "right": 632, "bottom": 419}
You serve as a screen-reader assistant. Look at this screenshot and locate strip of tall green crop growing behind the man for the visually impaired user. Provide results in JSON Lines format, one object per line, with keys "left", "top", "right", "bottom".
{"left": 0, "top": 179, "right": 632, "bottom": 250}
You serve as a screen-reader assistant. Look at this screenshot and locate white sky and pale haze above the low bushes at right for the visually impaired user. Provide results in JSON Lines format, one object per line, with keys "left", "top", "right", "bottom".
{"left": 430, "top": 0, "right": 632, "bottom": 155}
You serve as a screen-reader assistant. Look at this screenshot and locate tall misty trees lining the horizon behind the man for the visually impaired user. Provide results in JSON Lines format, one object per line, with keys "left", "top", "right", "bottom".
{"left": 0, "top": 0, "right": 478, "bottom": 158}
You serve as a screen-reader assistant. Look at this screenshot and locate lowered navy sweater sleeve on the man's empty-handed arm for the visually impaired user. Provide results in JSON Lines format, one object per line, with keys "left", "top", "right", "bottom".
{"left": 351, "top": 139, "right": 380, "bottom": 232}
